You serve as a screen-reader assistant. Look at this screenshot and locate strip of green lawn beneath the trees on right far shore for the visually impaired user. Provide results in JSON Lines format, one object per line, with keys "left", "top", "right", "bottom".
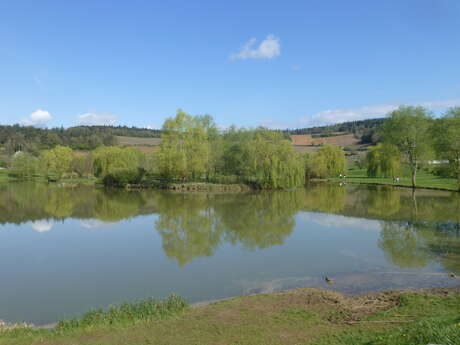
{"left": 330, "top": 169, "right": 458, "bottom": 190}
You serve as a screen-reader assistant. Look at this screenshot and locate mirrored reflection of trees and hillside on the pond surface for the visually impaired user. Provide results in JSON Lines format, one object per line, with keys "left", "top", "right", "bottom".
{"left": 0, "top": 184, "right": 460, "bottom": 273}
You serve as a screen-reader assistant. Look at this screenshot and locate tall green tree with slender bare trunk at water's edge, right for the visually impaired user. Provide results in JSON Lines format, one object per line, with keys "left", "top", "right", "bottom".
{"left": 381, "top": 106, "right": 432, "bottom": 187}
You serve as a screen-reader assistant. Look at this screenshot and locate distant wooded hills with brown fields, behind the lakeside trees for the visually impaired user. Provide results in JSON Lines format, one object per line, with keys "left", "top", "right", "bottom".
{"left": 0, "top": 119, "right": 383, "bottom": 155}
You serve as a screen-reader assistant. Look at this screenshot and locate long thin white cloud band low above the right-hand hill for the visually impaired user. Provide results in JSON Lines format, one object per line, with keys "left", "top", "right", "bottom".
{"left": 300, "top": 99, "right": 460, "bottom": 126}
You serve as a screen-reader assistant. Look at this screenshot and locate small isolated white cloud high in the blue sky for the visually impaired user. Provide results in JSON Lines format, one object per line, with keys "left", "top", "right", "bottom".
{"left": 230, "top": 35, "right": 281, "bottom": 60}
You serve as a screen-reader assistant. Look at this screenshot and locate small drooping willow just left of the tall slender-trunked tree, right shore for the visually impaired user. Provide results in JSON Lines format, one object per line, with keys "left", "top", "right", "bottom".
{"left": 366, "top": 143, "right": 401, "bottom": 177}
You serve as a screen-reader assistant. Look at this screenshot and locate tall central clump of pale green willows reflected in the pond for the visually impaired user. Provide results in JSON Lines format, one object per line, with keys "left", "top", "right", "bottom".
{"left": 156, "top": 111, "right": 304, "bottom": 188}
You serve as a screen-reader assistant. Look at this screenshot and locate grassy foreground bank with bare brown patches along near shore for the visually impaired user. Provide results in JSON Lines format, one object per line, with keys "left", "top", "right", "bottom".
{"left": 0, "top": 288, "right": 460, "bottom": 345}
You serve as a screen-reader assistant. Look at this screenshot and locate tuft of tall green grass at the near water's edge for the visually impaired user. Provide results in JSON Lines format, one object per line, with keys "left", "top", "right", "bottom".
{"left": 56, "top": 295, "right": 188, "bottom": 331}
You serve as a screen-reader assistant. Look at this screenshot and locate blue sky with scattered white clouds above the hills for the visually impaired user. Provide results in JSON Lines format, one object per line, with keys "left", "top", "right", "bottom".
{"left": 0, "top": 0, "right": 460, "bottom": 128}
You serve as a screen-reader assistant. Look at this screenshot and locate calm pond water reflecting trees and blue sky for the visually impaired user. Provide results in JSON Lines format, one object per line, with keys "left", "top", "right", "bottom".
{"left": 0, "top": 184, "right": 460, "bottom": 324}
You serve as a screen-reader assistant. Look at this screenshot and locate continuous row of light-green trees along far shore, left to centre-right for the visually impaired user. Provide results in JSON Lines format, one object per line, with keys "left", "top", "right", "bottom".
{"left": 4, "top": 110, "right": 345, "bottom": 189}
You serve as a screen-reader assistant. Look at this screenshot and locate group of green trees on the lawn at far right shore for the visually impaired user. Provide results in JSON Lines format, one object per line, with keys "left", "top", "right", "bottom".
{"left": 366, "top": 106, "right": 460, "bottom": 189}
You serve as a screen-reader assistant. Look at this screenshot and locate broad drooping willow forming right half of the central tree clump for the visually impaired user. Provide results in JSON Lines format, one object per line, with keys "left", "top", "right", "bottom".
{"left": 241, "top": 128, "right": 305, "bottom": 189}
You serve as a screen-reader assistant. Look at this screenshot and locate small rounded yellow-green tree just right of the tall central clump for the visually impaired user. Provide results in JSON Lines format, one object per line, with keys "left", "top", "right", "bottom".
{"left": 306, "top": 145, "right": 346, "bottom": 178}
